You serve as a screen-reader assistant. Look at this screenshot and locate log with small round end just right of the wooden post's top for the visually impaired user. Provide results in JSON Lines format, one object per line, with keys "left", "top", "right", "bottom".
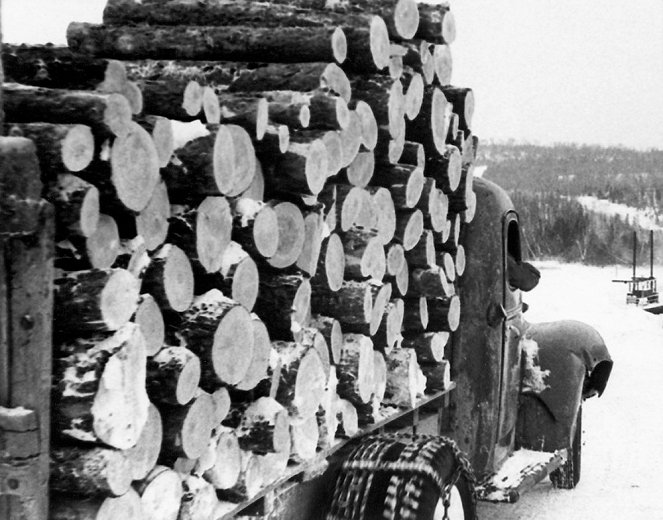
{"left": 5, "top": 123, "right": 95, "bottom": 179}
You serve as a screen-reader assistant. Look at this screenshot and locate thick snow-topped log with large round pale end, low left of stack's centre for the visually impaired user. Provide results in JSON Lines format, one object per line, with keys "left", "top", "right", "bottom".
{"left": 176, "top": 289, "right": 253, "bottom": 390}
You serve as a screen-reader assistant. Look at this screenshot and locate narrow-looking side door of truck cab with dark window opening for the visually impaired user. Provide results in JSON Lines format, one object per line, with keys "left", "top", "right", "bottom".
{"left": 495, "top": 211, "right": 522, "bottom": 464}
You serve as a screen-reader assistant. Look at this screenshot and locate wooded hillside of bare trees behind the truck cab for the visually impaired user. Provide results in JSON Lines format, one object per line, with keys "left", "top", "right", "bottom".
{"left": 477, "top": 142, "right": 663, "bottom": 265}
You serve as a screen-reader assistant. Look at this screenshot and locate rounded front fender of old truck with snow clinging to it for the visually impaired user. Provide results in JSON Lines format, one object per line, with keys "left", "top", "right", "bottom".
{"left": 518, "top": 320, "right": 612, "bottom": 450}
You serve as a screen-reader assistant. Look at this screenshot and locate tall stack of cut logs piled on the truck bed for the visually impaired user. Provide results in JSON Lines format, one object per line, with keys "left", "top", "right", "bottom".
{"left": 2, "top": 0, "right": 477, "bottom": 520}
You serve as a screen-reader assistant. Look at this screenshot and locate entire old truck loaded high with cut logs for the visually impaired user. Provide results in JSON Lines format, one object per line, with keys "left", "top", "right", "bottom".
{"left": 0, "top": 0, "right": 612, "bottom": 520}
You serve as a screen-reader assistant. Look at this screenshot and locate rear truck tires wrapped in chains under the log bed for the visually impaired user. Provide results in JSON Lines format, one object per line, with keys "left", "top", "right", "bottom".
{"left": 327, "top": 436, "right": 476, "bottom": 520}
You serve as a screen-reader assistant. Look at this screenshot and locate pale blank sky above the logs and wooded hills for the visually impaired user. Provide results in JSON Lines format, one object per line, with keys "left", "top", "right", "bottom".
{"left": 1, "top": 0, "right": 663, "bottom": 149}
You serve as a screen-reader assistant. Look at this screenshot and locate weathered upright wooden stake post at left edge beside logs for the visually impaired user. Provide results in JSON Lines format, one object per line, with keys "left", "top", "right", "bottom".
{"left": 0, "top": 137, "right": 55, "bottom": 520}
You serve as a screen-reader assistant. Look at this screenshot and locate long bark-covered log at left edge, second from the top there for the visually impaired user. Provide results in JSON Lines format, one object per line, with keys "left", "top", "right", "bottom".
{"left": 3, "top": 83, "right": 131, "bottom": 136}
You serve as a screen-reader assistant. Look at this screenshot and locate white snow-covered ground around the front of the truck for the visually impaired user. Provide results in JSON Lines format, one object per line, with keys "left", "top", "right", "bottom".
{"left": 478, "top": 264, "right": 663, "bottom": 520}
